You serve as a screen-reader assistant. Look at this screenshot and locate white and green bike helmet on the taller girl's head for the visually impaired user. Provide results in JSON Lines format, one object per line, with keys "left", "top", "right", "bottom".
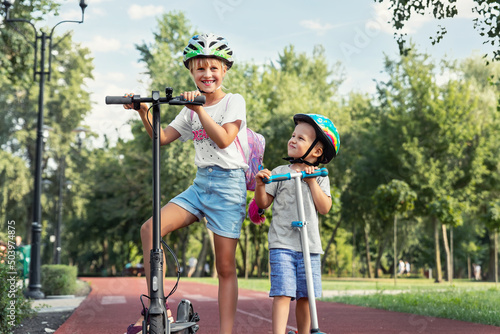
{"left": 184, "top": 33, "right": 234, "bottom": 69}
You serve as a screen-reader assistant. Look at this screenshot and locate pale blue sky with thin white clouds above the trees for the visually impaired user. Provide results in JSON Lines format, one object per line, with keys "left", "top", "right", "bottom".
{"left": 38, "top": 0, "right": 488, "bottom": 145}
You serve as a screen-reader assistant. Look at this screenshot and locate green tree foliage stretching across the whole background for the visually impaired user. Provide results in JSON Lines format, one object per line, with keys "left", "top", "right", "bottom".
{"left": 0, "top": 6, "right": 500, "bottom": 284}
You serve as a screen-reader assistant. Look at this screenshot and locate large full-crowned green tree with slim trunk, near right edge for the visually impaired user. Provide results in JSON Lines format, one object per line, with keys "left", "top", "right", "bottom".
{"left": 378, "top": 46, "right": 496, "bottom": 284}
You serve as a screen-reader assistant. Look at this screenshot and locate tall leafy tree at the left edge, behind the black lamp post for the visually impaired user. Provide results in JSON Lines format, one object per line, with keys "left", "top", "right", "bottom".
{"left": 0, "top": 0, "right": 93, "bottom": 242}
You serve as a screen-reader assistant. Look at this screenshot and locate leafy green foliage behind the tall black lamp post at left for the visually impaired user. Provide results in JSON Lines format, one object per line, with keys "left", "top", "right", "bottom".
{"left": 0, "top": 0, "right": 93, "bottom": 242}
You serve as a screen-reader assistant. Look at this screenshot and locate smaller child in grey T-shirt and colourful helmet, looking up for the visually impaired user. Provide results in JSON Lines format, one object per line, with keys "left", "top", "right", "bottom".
{"left": 255, "top": 114, "right": 339, "bottom": 334}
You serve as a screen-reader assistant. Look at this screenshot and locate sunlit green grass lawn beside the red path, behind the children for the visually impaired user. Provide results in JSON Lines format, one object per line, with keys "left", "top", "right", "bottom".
{"left": 182, "top": 277, "right": 500, "bottom": 326}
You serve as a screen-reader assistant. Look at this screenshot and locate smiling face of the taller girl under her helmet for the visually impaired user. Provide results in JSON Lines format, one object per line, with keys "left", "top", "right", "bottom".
{"left": 190, "top": 58, "right": 226, "bottom": 93}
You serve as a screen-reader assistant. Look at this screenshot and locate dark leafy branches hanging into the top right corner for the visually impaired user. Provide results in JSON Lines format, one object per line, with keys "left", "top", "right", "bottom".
{"left": 375, "top": 0, "right": 500, "bottom": 61}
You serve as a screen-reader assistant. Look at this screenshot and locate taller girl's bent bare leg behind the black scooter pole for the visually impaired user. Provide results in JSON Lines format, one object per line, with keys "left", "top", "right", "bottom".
{"left": 135, "top": 203, "right": 198, "bottom": 326}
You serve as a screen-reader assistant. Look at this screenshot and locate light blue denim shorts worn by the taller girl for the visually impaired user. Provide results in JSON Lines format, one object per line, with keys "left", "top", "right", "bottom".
{"left": 170, "top": 166, "right": 247, "bottom": 239}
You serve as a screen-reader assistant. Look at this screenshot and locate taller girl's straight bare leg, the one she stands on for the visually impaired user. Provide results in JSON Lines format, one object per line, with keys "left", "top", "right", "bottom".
{"left": 214, "top": 234, "right": 238, "bottom": 334}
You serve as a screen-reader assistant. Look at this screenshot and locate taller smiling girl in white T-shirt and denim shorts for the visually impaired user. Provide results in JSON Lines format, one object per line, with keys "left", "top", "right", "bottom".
{"left": 124, "top": 34, "right": 248, "bottom": 334}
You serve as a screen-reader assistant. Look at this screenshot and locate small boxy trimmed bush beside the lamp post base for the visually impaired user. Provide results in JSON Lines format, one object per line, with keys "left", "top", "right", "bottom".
{"left": 42, "top": 264, "right": 77, "bottom": 296}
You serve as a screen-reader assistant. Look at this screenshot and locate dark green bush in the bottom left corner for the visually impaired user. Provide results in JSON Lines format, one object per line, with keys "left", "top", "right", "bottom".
{"left": 0, "top": 262, "right": 34, "bottom": 333}
